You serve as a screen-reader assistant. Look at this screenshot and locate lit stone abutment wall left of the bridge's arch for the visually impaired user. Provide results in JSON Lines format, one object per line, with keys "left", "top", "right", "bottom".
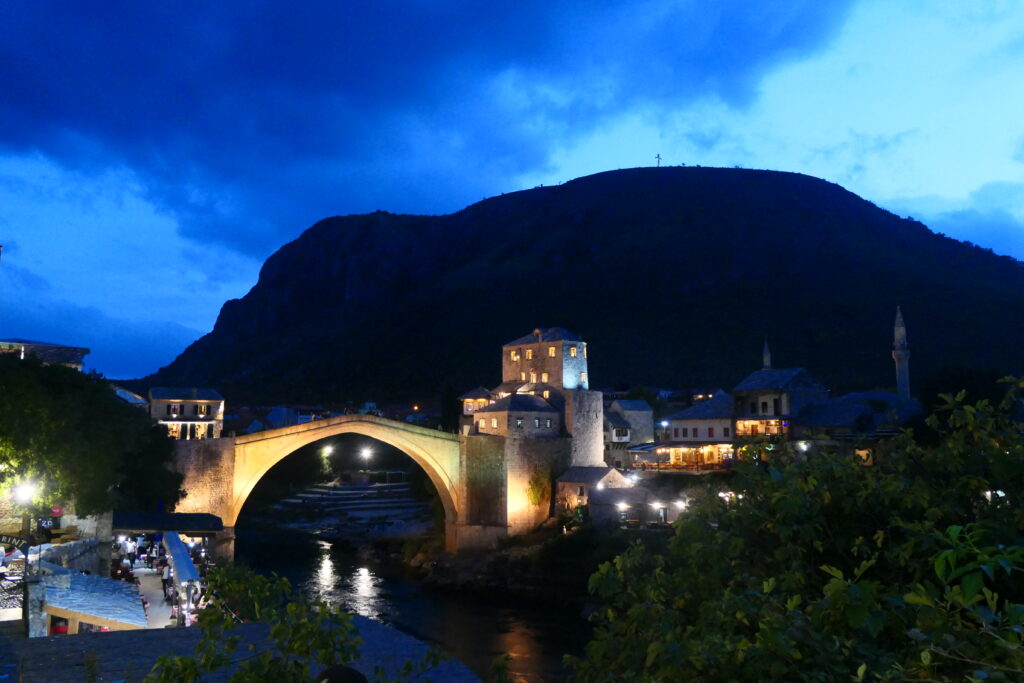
{"left": 174, "top": 438, "right": 234, "bottom": 519}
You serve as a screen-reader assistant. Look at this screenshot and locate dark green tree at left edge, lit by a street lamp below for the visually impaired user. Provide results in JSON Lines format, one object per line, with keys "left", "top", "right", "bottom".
{"left": 0, "top": 354, "right": 181, "bottom": 514}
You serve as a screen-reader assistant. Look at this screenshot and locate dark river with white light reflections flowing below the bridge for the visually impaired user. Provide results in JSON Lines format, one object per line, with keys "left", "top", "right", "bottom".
{"left": 234, "top": 526, "right": 589, "bottom": 683}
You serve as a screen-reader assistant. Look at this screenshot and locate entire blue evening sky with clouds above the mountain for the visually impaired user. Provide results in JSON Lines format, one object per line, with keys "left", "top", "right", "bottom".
{"left": 0, "top": 0, "right": 1024, "bottom": 377}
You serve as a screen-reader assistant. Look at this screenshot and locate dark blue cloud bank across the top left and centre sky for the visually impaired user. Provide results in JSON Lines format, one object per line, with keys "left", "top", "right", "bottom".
{"left": 0, "top": 0, "right": 850, "bottom": 255}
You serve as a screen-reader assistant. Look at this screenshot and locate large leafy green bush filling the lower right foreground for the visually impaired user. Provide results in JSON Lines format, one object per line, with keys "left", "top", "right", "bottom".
{"left": 571, "top": 382, "right": 1024, "bottom": 681}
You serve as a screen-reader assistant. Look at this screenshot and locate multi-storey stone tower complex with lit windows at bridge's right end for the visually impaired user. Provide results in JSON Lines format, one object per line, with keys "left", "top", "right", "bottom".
{"left": 459, "top": 328, "right": 628, "bottom": 547}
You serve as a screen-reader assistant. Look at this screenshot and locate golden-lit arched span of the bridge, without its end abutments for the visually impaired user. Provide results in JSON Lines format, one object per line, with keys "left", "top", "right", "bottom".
{"left": 230, "top": 415, "right": 461, "bottom": 544}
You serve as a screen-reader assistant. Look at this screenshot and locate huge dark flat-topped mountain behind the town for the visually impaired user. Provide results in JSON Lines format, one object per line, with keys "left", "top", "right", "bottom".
{"left": 146, "top": 168, "right": 1024, "bottom": 401}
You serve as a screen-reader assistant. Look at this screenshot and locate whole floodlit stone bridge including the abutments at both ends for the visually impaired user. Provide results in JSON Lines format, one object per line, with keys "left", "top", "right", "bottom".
{"left": 175, "top": 411, "right": 565, "bottom": 557}
